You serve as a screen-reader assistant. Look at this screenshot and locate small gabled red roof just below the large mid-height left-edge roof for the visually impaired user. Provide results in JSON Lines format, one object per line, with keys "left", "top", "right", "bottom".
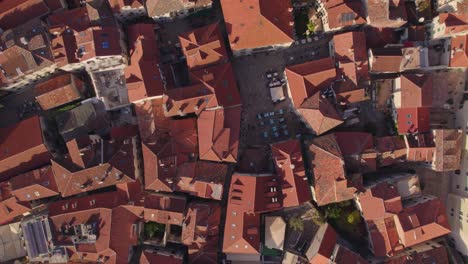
{"left": 9, "top": 166, "right": 59, "bottom": 202}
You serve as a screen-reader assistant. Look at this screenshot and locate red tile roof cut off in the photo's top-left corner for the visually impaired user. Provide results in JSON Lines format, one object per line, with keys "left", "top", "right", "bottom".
{"left": 0, "top": 0, "right": 50, "bottom": 30}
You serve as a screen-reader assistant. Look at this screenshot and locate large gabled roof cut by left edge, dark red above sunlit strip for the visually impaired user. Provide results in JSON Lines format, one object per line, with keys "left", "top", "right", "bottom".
{"left": 0, "top": 116, "right": 52, "bottom": 179}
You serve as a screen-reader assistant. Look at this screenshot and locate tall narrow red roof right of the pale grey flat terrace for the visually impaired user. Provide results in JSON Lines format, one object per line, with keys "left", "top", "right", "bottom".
{"left": 125, "top": 24, "right": 164, "bottom": 102}
